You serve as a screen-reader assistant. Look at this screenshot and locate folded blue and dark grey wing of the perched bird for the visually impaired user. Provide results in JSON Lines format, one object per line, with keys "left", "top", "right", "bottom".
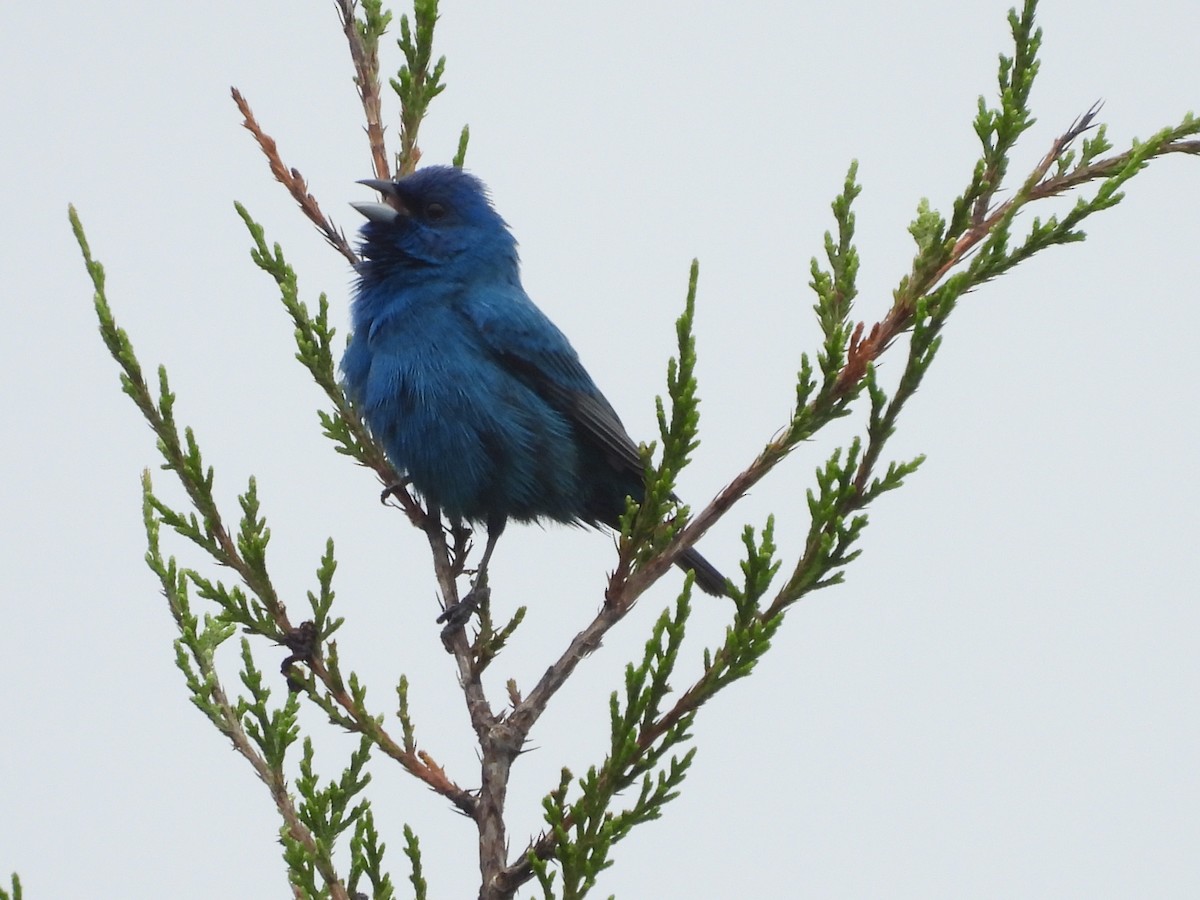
{"left": 463, "top": 286, "right": 642, "bottom": 479}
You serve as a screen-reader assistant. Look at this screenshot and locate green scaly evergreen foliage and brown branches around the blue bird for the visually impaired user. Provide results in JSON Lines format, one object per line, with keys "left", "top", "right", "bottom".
{"left": 70, "top": 0, "right": 1200, "bottom": 900}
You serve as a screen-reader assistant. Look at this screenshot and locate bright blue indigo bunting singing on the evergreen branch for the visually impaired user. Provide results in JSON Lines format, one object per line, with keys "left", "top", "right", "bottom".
{"left": 342, "top": 166, "right": 726, "bottom": 594}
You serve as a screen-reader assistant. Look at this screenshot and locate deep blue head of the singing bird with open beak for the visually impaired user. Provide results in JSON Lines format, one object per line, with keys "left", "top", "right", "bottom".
{"left": 350, "top": 166, "right": 516, "bottom": 277}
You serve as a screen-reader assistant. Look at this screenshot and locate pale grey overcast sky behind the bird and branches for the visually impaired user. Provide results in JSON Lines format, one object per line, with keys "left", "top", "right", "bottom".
{"left": 0, "top": 0, "right": 1200, "bottom": 900}
